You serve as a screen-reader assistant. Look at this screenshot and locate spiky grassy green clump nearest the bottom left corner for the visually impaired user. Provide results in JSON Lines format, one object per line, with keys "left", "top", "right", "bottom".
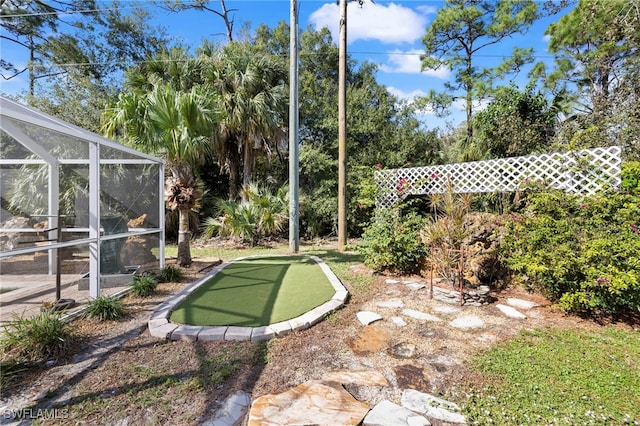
{"left": 0, "top": 310, "right": 77, "bottom": 362}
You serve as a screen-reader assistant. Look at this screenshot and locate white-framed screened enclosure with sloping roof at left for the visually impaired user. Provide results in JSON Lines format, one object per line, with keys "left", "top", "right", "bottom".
{"left": 0, "top": 97, "right": 164, "bottom": 316}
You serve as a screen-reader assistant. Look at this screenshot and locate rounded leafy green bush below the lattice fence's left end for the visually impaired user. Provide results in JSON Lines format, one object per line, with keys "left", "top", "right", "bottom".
{"left": 358, "top": 209, "right": 426, "bottom": 273}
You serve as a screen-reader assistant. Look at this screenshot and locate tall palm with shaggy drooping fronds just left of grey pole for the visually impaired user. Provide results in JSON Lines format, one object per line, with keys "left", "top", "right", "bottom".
{"left": 200, "top": 43, "right": 288, "bottom": 198}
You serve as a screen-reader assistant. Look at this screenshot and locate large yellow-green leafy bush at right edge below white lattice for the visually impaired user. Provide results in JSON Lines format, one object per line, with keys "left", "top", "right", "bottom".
{"left": 504, "top": 192, "right": 640, "bottom": 314}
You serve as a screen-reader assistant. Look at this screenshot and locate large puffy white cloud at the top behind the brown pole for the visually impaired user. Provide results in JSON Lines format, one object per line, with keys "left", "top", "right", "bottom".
{"left": 309, "top": 2, "right": 427, "bottom": 44}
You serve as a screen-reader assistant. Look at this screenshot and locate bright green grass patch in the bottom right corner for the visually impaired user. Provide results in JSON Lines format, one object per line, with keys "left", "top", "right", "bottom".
{"left": 463, "top": 327, "right": 640, "bottom": 425}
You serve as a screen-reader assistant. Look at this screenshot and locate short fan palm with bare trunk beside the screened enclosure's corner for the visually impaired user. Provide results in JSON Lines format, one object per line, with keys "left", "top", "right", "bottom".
{"left": 103, "top": 83, "right": 222, "bottom": 266}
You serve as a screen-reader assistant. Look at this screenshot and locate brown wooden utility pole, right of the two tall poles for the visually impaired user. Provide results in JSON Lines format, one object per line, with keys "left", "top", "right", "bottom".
{"left": 338, "top": 0, "right": 347, "bottom": 251}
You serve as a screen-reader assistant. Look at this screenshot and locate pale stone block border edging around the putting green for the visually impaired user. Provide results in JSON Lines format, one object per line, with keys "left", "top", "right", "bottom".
{"left": 148, "top": 255, "right": 349, "bottom": 342}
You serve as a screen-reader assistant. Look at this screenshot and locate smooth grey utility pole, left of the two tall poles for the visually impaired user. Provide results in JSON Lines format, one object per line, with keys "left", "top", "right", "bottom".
{"left": 289, "top": 0, "right": 300, "bottom": 253}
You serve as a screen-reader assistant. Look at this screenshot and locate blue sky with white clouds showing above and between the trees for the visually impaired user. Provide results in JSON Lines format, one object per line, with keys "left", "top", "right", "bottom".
{"left": 0, "top": 0, "right": 558, "bottom": 128}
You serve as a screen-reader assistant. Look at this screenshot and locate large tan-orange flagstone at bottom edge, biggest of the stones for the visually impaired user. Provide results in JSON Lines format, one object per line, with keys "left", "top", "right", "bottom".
{"left": 248, "top": 380, "right": 370, "bottom": 426}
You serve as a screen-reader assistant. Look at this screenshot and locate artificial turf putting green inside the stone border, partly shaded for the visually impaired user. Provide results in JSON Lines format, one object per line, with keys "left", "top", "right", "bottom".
{"left": 171, "top": 256, "right": 335, "bottom": 327}
